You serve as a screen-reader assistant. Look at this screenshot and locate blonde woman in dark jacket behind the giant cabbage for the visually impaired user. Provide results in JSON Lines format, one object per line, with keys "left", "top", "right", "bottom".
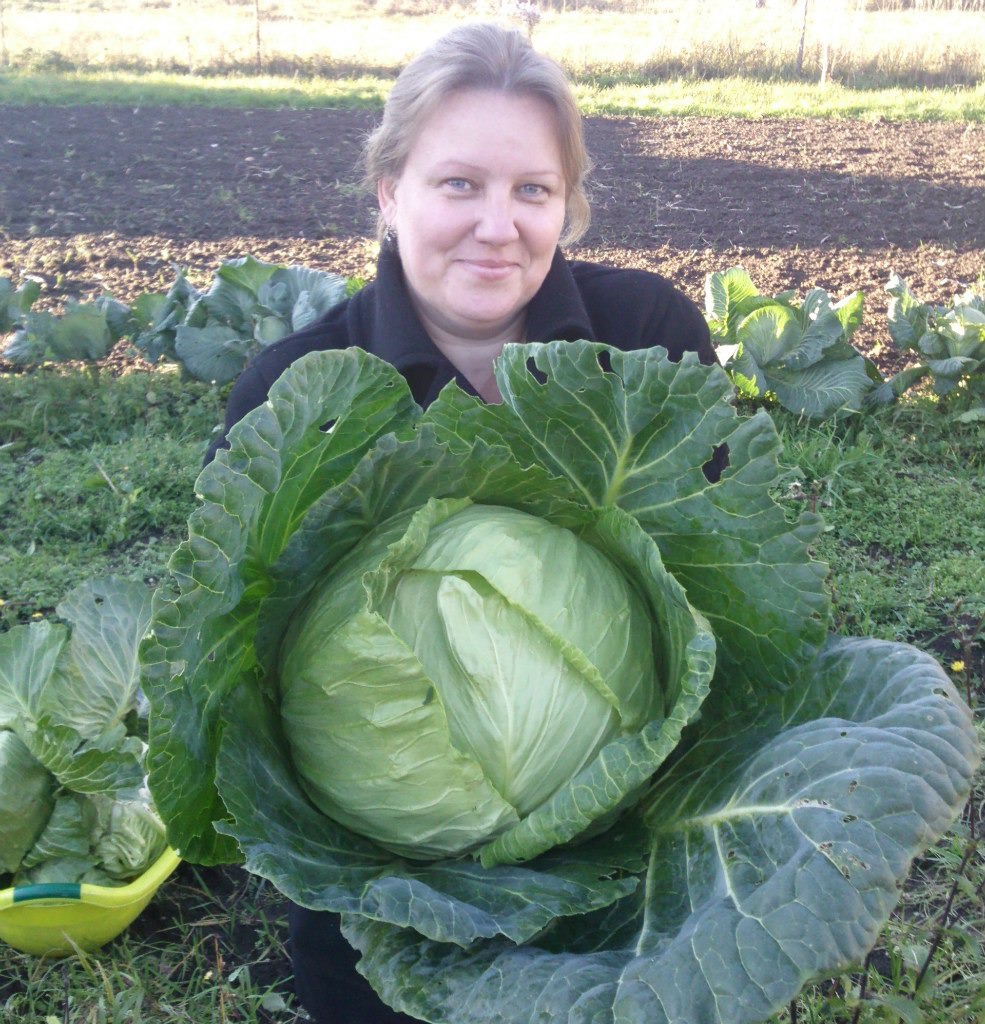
{"left": 210, "top": 18, "right": 724, "bottom": 1024}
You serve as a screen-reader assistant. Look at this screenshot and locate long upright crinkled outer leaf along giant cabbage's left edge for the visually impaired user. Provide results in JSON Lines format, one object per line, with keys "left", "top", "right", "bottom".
{"left": 142, "top": 350, "right": 420, "bottom": 862}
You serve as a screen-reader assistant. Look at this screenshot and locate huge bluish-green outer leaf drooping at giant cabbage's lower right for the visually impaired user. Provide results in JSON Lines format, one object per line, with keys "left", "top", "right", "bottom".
{"left": 345, "top": 639, "right": 978, "bottom": 1024}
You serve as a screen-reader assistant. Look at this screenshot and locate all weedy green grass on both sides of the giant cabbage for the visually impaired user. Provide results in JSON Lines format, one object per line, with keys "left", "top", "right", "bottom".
{"left": 0, "top": 367, "right": 985, "bottom": 1024}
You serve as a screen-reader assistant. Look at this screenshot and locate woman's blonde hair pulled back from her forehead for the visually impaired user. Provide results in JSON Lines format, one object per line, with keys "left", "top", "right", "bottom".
{"left": 362, "top": 24, "right": 592, "bottom": 245}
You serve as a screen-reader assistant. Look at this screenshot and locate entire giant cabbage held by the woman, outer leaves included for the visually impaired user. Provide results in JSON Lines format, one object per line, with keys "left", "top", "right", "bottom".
{"left": 142, "top": 342, "right": 978, "bottom": 1024}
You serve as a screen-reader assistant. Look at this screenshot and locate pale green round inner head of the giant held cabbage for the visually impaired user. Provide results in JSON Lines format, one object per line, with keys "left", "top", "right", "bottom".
{"left": 279, "top": 500, "right": 662, "bottom": 859}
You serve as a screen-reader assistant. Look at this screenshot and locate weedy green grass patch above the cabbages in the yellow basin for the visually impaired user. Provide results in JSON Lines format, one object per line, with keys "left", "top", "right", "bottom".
{"left": 0, "top": 367, "right": 222, "bottom": 623}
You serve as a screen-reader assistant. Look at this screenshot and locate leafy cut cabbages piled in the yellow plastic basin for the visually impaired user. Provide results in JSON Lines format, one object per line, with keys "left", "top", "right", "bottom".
{"left": 0, "top": 577, "right": 166, "bottom": 888}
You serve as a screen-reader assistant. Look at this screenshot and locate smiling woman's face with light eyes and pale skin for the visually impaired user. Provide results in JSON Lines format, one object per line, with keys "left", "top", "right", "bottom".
{"left": 379, "top": 90, "right": 566, "bottom": 340}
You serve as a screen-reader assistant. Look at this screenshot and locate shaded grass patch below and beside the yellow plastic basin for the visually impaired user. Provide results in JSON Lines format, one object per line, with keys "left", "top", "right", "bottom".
{"left": 0, "top": 864, "right": 299, "bottom": 1024}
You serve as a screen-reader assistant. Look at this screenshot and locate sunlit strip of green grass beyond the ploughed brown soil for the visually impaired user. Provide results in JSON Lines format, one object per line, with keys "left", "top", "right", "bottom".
{"left": 0, "top": 70, "right": 985, "bottom": 122}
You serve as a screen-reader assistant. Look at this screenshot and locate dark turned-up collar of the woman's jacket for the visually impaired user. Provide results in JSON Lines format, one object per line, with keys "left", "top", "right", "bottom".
{"left": 360, "top": 245, "right": 595, "bottom": 408}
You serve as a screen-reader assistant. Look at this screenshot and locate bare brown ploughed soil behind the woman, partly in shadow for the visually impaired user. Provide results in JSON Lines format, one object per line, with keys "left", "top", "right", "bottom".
{"left": 0, "top": 106, "right": 985, "bottom": 371}
